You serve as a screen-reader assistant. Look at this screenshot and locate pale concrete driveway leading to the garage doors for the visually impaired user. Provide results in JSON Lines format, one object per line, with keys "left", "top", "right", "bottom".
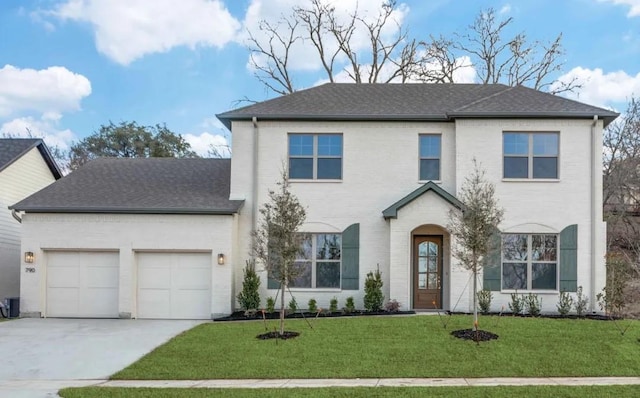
{"left": 0, "top": 318, "right": 202, "bottom": 397}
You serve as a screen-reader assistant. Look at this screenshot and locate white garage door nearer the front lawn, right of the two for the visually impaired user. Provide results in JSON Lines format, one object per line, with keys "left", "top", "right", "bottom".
{"left": 137, "top": 253, "right": 211, "bottom": 319}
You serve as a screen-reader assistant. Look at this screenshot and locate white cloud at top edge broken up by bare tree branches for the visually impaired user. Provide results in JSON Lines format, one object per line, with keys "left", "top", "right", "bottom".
{"left": 239, "top": 0, "right": 409, "bottom": 72}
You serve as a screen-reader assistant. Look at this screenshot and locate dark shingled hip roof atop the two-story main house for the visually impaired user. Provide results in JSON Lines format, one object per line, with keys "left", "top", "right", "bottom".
{"left": 217, "top": 83, "right": 618, "bottom": 129}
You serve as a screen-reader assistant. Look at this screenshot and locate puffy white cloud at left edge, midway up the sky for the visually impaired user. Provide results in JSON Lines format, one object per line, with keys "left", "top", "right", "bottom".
{"left": 0, "top": 65, "right": 91, "bottom": 119}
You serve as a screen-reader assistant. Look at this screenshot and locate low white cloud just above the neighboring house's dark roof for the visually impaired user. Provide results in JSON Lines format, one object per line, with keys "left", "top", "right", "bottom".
{"left": 0, "top": 116, "right": 76, "bottom": 150}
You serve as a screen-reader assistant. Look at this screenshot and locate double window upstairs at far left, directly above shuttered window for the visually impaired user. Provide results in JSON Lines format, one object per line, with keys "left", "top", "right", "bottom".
{"left": 289, "top": 134, "right": 342, "bottom": 180}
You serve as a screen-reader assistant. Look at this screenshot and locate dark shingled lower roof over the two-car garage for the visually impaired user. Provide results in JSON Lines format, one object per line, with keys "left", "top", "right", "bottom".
{"left": 10, "top": 158, "right": 243, "bottom": 214}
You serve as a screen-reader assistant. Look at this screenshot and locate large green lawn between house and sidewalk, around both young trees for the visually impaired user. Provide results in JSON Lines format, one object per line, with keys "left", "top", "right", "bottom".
{"left": 112, "top": 316, "right": 640, "bottom": 379}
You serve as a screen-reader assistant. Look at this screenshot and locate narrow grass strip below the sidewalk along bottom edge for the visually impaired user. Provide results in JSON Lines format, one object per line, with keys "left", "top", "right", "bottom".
{"left": 59, "top": 386, "right": 640, "bottom": 398}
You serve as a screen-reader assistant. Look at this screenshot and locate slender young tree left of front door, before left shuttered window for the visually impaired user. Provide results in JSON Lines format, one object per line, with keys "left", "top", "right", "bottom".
{"left": 252, "top": 168, "right": 306, "bottom": 335}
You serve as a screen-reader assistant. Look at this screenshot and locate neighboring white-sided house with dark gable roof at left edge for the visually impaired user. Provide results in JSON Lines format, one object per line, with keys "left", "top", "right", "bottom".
{"left": 0, "top": 138, "right": 62, "bottom": 300}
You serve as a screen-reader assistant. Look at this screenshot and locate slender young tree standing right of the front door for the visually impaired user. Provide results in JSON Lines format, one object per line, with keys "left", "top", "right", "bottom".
{"left": 448, "top": 159, "right": 504, "bottom": 331}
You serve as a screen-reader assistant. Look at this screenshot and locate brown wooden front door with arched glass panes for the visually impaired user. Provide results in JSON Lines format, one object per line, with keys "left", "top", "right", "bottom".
{"left": 413, "top": 235, "right": 442, "bottom": 309}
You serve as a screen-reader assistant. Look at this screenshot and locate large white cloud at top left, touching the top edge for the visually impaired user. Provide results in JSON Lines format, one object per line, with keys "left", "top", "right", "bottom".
{"left": 47, "top": 0, "right": 240, "bottom": 65}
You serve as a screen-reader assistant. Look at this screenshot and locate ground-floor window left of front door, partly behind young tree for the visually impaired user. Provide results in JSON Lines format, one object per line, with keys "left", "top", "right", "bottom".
{"left": 291, "top": 234, "right": 342, "bottom": 289}
